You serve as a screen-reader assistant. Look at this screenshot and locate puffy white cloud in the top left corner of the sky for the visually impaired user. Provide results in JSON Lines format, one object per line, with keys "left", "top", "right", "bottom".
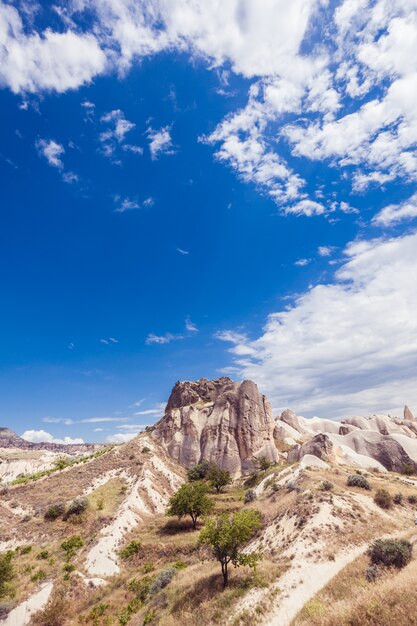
{"left": 0, "top": 2, "right": 106, "bottom": 93}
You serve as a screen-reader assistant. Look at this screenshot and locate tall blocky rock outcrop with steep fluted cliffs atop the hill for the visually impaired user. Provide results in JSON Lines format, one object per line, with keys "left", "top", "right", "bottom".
{"left": 152, "top": 377, "right": 278, "bottom": 476}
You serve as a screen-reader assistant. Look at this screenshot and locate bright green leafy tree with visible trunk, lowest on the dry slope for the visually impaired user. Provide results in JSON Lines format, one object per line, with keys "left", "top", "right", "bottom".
{"left": 199, "top": 509, "right": 262, "bottom": 588}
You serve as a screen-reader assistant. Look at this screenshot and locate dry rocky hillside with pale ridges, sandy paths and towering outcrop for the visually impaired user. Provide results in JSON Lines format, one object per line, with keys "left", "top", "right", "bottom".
{"left": 0, "top": 378, "right": 417, "bottom": 626}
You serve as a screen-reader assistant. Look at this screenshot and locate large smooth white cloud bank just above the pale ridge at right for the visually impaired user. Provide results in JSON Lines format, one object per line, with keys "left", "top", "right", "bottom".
{"left": 221, "top": 233, "right": 417, "bottom": 418}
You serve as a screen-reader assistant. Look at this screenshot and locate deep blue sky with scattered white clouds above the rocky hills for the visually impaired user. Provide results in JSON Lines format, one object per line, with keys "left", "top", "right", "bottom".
{"left": 0, "top": 0, "right": 417, "bottom": 441}
